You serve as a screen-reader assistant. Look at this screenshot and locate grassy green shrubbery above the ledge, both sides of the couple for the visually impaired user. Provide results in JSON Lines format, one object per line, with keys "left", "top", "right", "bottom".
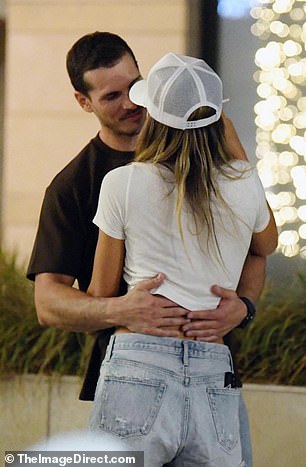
{"left": 0, "top": 253, "right": 306, "bottom": 386}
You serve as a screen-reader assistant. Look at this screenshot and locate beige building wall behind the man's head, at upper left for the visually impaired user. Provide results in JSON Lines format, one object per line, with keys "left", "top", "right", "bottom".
{"left": 3, "top": 0, "right": 187, "bottom": 260}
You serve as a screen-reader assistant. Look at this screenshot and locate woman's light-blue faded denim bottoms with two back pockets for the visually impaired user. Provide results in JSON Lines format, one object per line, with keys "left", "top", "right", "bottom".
{"left": 90, "top": 334, "right": 245, "bottom": 467}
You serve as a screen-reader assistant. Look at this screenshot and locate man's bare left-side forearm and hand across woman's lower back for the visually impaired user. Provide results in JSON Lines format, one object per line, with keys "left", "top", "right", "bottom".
{"left": 35, "top": 273, "right": 186, "bottom": 337}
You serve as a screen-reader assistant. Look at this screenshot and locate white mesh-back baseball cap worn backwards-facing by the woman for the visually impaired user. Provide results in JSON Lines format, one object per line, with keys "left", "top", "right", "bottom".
{"left": 129, "top": 52, "right": 223, "bottom": 130}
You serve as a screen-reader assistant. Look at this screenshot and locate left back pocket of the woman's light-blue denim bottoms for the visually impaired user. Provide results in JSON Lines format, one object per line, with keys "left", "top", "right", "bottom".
{"left": 100, "top": 376, "right": 166, "bottom": 437}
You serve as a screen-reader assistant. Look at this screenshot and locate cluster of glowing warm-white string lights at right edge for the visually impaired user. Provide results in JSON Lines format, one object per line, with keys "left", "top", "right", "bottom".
{"left": 251, "top": 0, "right": 306, "bottom": 259}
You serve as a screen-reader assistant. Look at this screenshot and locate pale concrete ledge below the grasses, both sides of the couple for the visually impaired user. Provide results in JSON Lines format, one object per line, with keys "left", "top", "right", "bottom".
{"left": 0, "top": 375, "right": 306, "bottom": 467}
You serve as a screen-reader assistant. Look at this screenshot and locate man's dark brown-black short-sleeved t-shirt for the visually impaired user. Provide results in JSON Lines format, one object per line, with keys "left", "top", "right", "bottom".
{"left": 27, "top": 135, "right": 134, "bottom": 400}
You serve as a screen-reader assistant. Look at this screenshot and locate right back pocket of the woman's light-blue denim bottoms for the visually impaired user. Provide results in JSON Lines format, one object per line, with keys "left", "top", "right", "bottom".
{"left": 207, "top": 388, "right": 240, "bottom": 452}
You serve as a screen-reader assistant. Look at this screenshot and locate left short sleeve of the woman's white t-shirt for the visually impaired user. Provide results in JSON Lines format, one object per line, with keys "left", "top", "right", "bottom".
{"left": 93, "top": 167, "right": 127, "bottom": 240}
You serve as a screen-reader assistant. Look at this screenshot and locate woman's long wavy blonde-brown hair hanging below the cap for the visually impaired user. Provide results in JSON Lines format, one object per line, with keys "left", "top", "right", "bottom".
{"left": 134, "top": 107, "right": 241, "bottom": 259}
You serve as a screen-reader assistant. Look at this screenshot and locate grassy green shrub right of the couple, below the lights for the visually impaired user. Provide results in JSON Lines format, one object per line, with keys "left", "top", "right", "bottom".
{"left": 236, "top": 274, "right": 306, "bottom": 386}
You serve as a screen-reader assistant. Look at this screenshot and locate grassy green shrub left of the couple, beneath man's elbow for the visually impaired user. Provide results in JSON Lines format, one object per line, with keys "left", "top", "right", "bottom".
{"left": 0, "top": 252, "right": 92, "bottom": 374}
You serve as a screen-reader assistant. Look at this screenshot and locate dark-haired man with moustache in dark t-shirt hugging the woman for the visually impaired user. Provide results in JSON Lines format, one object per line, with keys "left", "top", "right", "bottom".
{"left": 28, "top": 32, "right": 264, "bottom": 466}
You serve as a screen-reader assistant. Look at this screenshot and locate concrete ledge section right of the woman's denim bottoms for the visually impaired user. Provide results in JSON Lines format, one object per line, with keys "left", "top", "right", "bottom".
{"left": 243, "top": 384, "right": 306, "bottom": 467}
